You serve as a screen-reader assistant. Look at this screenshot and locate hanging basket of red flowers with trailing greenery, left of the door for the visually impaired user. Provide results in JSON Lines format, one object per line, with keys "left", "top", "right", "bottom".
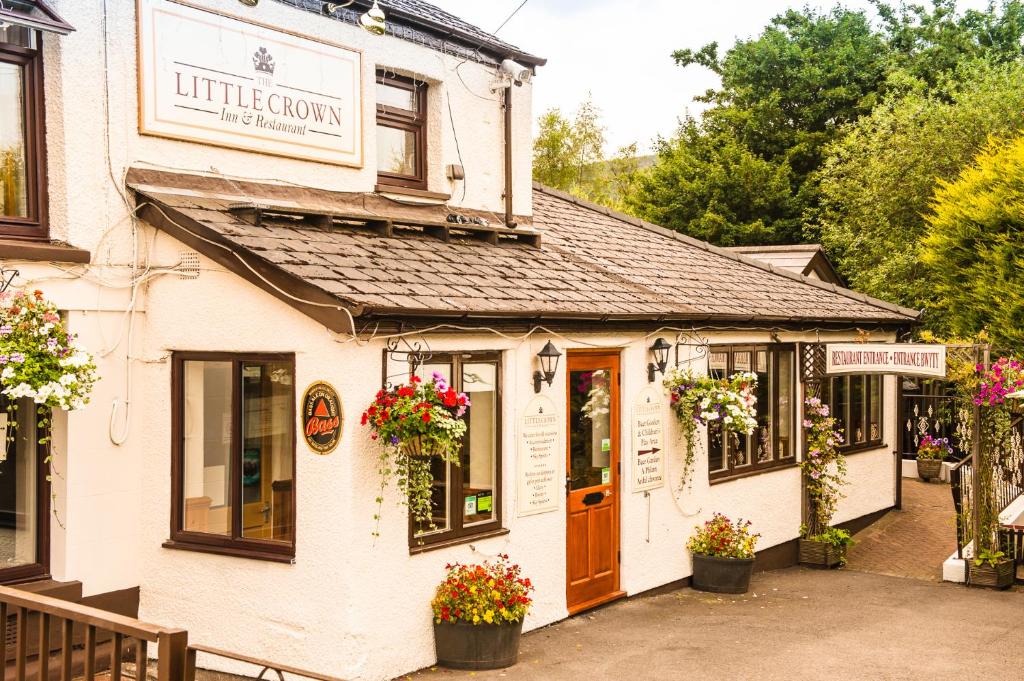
{"left": 361, "top": 373, "right": 469, "bottom": 536}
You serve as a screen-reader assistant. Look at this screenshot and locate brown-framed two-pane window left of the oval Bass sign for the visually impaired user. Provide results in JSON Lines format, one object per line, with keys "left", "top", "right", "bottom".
{"left": 165, "top": 352, "right": 295, "bottom": 561}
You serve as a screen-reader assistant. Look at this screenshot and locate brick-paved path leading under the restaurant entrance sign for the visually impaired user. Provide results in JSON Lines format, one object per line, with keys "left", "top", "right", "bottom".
{"left": 847, "top": 478, "right": 956, "bottom": 582}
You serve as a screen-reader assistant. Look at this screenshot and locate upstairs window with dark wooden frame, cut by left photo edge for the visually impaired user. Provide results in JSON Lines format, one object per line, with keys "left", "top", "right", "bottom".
{"left": 0, "top": 22, "right": 48, "bottom": 239}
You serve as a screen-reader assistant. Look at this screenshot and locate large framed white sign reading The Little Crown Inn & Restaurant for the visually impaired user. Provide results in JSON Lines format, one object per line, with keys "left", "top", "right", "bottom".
{"left": 137, "top": 0, "right": 362, "bottom": 167}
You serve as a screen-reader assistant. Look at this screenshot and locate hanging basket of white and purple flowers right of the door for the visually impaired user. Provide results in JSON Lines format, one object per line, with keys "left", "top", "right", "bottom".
{"left": 665, "top": 369, "right": 758, "bottom": 486}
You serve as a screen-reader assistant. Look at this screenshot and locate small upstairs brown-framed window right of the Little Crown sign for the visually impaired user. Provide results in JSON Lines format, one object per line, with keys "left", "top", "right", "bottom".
{"left": 377, "top": 72, "right": 427, "bottom": 190}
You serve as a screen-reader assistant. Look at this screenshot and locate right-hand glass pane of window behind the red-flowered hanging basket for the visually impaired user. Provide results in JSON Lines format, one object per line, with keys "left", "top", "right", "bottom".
{"left": 462, "top": 364, "right": 498, "bottom": 525}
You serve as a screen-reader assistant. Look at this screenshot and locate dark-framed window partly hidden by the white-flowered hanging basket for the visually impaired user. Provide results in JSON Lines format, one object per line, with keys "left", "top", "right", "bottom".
{"left": 708, "top": 345, "right": 797, "bottom": 480}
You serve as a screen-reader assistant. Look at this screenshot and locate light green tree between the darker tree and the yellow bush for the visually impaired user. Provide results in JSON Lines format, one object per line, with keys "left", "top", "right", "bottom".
{"left": 806, "top": 62, "right": 1024, "bottom": 308}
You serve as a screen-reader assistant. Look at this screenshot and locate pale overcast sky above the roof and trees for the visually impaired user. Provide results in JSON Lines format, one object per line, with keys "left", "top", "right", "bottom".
{"left": 430, "top": 0, "right": 988, "bottom": 154}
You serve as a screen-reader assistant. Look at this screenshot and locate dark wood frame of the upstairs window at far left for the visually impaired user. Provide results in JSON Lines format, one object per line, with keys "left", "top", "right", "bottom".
{"left": 0, "top": 39, "right": 49, "bottom": 240}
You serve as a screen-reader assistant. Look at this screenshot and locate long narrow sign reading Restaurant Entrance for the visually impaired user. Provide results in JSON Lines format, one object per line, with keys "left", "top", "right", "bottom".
{"left": 825, "top": 343, "right": 946, "bottom": 378}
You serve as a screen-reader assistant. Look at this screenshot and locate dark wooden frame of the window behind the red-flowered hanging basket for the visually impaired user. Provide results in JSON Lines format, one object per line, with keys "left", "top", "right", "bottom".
{"left": 407, "top": 350, "right": 509, "bottom": 553}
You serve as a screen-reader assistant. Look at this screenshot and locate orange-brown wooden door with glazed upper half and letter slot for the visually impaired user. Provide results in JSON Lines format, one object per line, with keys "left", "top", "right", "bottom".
{"left": 565, "top": 352, "right": 623, "bottom": 613}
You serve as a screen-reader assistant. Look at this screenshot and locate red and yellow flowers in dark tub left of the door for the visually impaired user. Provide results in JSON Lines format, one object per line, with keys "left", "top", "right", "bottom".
{"left": 431, "top": 555, "right": 534, "bottom": 670}
